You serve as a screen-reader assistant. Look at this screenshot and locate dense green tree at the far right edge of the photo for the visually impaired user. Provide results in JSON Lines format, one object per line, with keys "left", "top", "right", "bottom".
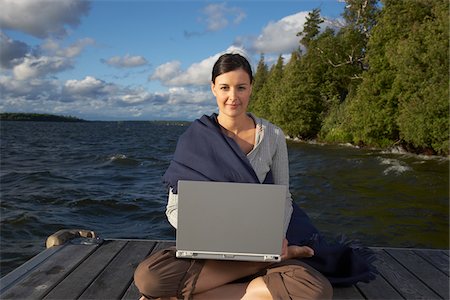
{"left": 392, "top": 0, "right": 449, "bottom": 154}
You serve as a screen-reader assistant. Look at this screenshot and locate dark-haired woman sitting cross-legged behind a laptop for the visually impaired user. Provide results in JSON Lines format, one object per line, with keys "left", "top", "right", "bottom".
{"left": 135, "top": 54, "right": 374, "bottom": 299}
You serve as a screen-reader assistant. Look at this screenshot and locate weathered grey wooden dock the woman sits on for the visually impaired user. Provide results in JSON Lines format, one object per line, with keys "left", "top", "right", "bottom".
{"left": 0, "top": 239, "right": 449, "bottom": 300}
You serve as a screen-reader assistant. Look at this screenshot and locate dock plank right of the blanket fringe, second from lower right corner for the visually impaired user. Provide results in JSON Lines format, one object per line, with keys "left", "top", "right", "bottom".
{"left": 370, "top": 251, "right": 439, "bottom": 299}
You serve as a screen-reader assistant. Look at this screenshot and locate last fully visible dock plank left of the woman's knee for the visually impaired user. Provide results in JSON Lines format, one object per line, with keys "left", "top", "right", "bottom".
{"left": 79, "top": 241, "right": 153, "bottom": 299}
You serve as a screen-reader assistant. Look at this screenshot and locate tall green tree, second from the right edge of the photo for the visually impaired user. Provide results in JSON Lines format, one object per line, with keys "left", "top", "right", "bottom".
{"left": 346, "top": 0, "right": 448, "bottom": 146}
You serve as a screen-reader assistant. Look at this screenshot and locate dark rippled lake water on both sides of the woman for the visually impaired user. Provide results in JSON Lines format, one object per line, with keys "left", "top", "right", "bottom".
{"left": 0, "top": 122, "right": 449, "bottom": 276}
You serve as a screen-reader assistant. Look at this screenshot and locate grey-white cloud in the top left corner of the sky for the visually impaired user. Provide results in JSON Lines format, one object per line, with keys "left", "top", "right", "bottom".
{"left": 0, "top": 0, "right": 90, "bottom": 38}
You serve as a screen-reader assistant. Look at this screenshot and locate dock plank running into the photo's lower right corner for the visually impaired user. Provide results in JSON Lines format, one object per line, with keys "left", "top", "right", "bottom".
{"left": 386, "top": 249, "right": 449, "bottom": 299}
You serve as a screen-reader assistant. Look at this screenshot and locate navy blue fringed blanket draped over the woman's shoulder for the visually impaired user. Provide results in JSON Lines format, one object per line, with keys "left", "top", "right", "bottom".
{"left": 163, "top": 114, "right": 376, "bottom": 285}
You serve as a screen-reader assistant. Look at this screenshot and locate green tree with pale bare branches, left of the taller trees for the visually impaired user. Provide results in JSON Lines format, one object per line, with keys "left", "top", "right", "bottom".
{"left": 301, "top": 0, "right": 378, "bottom": 142}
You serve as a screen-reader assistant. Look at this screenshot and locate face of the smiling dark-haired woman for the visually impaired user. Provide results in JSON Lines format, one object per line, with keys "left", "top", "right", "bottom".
{"left": 211, "top": 69, "right": 252, "bottom": 117}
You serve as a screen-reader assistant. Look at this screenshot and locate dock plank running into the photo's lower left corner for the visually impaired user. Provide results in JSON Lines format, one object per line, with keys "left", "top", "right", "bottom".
{"left": 0, "top": 244, "right": 99, "bottom": 299}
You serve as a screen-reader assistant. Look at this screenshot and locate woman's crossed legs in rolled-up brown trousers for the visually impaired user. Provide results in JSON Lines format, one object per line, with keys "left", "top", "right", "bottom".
{"left": 134, "top": 248, "right": 332, "bottom": 300}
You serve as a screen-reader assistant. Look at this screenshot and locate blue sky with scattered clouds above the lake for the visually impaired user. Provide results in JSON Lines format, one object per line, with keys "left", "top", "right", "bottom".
{"left": 0, "top": 0, "right": 345, "bottom": 120}
